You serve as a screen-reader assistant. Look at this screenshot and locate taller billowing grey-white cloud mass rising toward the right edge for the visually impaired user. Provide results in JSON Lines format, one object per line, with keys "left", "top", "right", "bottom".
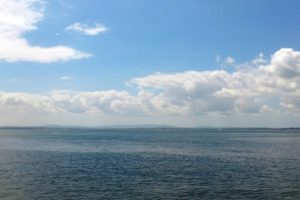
{"left": 131, "top": 48, "right": 300, "bottom": 114}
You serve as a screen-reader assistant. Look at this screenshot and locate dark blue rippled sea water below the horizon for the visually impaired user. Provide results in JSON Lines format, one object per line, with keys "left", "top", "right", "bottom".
{"left": 0, "top": 129, "right": 300, "bottom": 200}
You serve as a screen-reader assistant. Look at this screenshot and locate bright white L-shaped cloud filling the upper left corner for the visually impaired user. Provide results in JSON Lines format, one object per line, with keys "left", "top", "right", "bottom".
{"left": 0, "top": 0, "right": 90, "bottom": 63}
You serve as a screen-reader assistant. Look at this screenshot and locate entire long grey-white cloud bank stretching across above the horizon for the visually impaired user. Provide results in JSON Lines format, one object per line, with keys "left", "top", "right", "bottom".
{"left": 0, "top": 48, "right": 300, "bottom": 126}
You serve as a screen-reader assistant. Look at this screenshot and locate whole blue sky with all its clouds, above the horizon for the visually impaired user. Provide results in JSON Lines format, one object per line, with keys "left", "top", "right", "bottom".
{"left": 0, "top": 0, "right": 300, "bottom": 127}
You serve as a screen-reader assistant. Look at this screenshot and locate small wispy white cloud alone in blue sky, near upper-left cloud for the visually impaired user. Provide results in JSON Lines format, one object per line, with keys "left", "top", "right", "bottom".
{"left": 66, "top": 22, "right": 107, "bottom": 36}
